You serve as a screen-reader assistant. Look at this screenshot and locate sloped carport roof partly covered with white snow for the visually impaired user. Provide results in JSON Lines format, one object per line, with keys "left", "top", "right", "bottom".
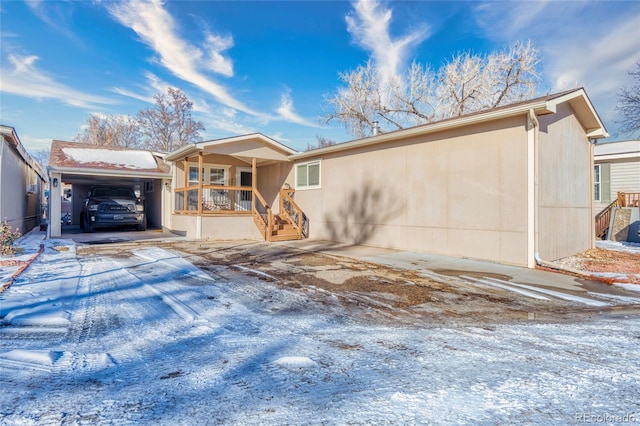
{"left": 49, "top": 140, "right": 171, "bottom": 178}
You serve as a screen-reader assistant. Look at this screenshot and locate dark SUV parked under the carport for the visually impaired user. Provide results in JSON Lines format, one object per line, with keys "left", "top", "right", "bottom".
{"left": 80, "top": 186, "right": 147, "bottom": 232}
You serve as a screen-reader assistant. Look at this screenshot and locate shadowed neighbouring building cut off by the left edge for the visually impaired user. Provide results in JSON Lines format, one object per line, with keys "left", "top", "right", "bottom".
{"left": 0, "top": 125, "right": 47, "bottom": 234}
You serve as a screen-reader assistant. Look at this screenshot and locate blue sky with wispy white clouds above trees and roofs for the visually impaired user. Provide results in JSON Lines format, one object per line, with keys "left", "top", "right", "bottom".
{"left": 0, "top": 0, "right": 640, "bottom": 151}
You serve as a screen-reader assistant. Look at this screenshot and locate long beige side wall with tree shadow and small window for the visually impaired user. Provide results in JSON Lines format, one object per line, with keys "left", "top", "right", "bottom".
{"left": 288, "top": 115, "right": 527, "bottom": 265}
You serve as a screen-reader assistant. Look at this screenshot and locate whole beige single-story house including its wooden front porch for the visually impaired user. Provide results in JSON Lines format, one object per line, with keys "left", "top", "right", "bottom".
{"left": 47, "top": 89, "right": 608, "bottom": 267}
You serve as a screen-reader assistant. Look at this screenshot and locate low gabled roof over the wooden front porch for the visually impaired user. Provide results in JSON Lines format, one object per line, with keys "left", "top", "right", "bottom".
{"left": 165, "top": 133, "right": 298, "bottom": 165}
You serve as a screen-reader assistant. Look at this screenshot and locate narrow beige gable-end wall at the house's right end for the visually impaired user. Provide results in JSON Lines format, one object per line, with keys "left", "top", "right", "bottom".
{"left": 536, "top": 104, "right": 595, "bottom": 260}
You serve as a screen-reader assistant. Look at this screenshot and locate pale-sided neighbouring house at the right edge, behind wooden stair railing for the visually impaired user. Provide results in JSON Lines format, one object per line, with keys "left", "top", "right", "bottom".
{"left": 593, "top": 140, "right": 640, "bottom": 213}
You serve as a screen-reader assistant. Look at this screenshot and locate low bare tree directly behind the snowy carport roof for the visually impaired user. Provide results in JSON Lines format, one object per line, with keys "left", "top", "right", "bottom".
{"left": 74, "top": 114, "right": 141, "bottom": 148}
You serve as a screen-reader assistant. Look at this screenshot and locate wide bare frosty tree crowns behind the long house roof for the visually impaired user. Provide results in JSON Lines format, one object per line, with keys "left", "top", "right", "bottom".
{"left": 325, "top": 42, "right": 540, "bottom": 138}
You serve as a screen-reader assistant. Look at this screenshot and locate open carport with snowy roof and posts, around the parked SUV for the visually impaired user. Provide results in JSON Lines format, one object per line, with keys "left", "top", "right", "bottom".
{"left": 48, "top": 140, "right": 171, "bottom": 238}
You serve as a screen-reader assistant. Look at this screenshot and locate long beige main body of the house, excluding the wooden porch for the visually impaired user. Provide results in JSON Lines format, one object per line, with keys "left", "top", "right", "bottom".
{"left": 287, "top": 89, "right": 607, "bottom": 267}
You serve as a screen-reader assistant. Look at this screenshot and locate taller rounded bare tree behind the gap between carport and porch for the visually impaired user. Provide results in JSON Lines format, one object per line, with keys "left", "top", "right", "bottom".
{"left": 137, "top": 88, "right": 205, "bottom": 152}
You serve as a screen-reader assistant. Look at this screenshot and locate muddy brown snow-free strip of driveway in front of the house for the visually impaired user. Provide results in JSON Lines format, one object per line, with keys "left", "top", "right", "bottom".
{"left": 77, "top": 241, "right": 636, "bottom": 324}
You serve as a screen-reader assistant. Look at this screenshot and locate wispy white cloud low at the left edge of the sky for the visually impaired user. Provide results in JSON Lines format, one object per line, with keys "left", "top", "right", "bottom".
{"left": 0, "top": 54, "right": 115, "bottom": 108}
